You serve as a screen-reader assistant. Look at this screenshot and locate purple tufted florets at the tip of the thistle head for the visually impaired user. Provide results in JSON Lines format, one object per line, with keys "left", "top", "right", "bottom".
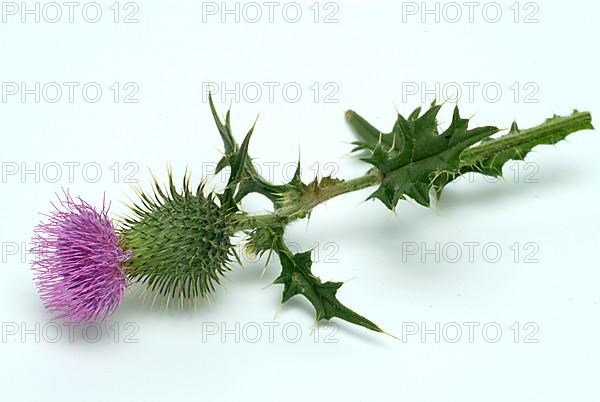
{"left": 32, "top": 191, "right": 129, "bottom": 323}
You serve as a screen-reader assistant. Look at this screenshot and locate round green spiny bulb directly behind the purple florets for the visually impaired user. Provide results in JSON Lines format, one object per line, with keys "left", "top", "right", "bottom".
{"left": 121, "top": 174, "right": 235, "bottom": 303}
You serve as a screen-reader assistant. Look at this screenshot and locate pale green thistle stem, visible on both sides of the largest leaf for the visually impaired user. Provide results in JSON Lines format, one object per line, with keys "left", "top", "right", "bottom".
{"left": 235, "top": 112, "right": 592, "bottom": 231}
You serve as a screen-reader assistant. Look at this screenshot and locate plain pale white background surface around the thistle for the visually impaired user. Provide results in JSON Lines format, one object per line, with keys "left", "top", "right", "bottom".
{"left": 0, "top": 0, "right": 600, "bottom": 401}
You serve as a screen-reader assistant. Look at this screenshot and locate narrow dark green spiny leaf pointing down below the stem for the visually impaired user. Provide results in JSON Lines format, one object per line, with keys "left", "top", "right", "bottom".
{"left": 273, "top": 240, "right": 383, "bottom": 332}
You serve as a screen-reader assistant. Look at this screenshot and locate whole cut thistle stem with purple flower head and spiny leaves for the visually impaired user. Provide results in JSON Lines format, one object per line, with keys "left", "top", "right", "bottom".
{"left": 28, "top": 94, "right": 593, "bottom": 332}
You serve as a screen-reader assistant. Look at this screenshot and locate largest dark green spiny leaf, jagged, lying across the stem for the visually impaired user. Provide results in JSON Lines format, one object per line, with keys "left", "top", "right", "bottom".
{"left": 346, "top": 103, "right": 499, "bottom": 210}
